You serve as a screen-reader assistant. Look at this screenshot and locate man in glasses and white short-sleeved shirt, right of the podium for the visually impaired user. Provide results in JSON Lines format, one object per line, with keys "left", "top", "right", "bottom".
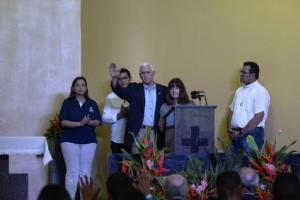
{"left": 227, "top": 62, "right": 270, "bottom": 153}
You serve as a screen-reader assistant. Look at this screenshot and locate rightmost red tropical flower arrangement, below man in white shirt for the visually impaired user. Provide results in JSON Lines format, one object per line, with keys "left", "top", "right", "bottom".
{"left": 244, "top": 131, "right": 296, "bottom": 200}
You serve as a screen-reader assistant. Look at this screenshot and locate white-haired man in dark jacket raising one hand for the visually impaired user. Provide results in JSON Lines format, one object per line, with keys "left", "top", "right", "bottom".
{"left": 109, "top": 63, "right": 167, "bottom": 154}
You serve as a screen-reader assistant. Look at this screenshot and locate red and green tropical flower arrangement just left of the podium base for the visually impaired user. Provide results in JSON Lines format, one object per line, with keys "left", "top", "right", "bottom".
{"left": 121, "top": 127, "right": 169, "bottom": 200}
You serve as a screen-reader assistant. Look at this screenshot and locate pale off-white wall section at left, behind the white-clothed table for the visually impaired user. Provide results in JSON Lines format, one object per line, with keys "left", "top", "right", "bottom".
{"left": 0, "top": 0, "right": 81, "bottom": 200}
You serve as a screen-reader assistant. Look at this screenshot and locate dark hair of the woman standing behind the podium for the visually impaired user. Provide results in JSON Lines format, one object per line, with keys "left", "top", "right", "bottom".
{"left": 166, "top": 78, "right": 190, "bottom": 105}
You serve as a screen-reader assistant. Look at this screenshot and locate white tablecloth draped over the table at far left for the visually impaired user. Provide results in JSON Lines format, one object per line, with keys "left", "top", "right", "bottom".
{"left": 0, "top": 136, "right": 52, "bottom": 165}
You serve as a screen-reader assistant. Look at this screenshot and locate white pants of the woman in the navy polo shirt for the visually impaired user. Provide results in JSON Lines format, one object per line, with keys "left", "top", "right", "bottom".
{"left": 61, "top": 142, "right": 97, "bottom": 200}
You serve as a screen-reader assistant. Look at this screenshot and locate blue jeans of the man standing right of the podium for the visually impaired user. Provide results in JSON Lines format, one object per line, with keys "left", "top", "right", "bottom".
{"left": 231, "top": 127, "right": 265, "bottom": 153}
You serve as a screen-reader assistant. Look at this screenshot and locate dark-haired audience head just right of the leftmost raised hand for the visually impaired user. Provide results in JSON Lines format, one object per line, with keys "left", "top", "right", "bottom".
{"left": 106, "top": 172, "right": 133, "bottom": 200}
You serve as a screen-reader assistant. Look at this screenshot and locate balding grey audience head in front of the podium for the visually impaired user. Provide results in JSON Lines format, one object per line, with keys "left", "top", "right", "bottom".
{"left": 164, "top": 174, "right": 188, "bottom": 200}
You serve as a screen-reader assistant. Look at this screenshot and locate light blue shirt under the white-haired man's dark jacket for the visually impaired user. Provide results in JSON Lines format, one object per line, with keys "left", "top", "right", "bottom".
{"left": 143, "top": 84, "right": 156, "bottom": 126}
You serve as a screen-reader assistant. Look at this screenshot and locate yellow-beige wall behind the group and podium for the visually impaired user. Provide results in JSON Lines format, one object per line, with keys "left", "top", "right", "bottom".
{"left": 81, "top": 0, "right": 300, "bottom": 197}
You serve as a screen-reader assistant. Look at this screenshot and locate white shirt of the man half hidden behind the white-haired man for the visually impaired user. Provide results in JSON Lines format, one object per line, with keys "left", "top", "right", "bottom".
{"left": 102, "top": 92, "right": 129, "bottom": 144}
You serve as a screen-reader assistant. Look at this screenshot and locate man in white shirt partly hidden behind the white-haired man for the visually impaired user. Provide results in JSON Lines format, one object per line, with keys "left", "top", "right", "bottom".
{"left": 102, "top": 68, "right": 131, "bottom": 153}
